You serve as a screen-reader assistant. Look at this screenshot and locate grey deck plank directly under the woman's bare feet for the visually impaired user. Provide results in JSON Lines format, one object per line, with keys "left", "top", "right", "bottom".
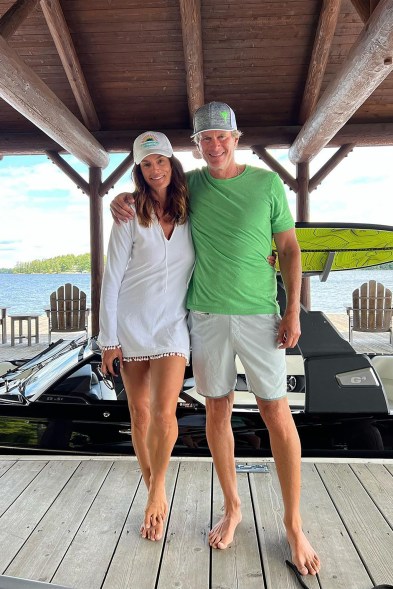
{"left": 103, "top": 462, "right": 178, "bottom": 589}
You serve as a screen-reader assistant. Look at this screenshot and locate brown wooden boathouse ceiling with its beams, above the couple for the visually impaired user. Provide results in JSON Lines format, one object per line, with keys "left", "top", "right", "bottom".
{"left": 0, "top": 0, "right": 393, "bottom": 167}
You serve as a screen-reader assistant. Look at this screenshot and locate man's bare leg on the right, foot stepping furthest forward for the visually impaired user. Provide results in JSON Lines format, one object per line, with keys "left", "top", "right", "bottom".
{"left": 257, "top": 397, "right": 320, "bottom": 575}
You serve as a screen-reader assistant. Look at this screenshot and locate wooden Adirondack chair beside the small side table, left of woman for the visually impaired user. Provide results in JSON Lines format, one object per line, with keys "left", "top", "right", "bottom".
{"left": 45, "top": 283, "right": 89, "bottom": 343}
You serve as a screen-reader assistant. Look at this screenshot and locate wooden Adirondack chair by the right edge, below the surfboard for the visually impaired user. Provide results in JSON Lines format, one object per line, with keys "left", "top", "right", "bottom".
{"left": 347, "top": 280, "right": 393, "bottom": 345}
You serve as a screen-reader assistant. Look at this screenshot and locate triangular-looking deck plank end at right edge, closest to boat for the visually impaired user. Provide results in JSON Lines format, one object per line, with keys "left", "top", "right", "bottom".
{"left": 351, "top": 463, "right": 393, "bottom": 527}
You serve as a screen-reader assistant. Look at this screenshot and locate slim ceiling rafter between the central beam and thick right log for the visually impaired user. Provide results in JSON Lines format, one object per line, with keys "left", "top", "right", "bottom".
{"left": 299, "top": 0, "right": 341, "bottom": 124}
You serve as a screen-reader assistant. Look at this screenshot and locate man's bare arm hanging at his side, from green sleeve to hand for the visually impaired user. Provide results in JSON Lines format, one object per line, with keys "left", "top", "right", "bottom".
{"left": 274, "top": 229, "right": 302, "bottom": 348}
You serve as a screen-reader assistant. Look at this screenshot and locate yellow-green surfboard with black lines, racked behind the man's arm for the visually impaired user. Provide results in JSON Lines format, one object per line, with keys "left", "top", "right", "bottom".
{"left": 273, "top": 223, "right": 393, "bottom": 279}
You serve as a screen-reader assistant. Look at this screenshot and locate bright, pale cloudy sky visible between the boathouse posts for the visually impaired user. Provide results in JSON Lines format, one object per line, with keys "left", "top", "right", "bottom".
{"left": 0, "top": 147, "right": 393, "bottom": 268}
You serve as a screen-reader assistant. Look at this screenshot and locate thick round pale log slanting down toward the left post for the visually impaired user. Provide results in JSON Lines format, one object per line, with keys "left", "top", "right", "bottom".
{"left": 0, "top": 37, "right": 109, "bottom": 168}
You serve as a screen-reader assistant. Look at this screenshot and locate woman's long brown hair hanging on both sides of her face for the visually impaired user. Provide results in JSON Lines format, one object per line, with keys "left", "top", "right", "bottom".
{"left": 132, "top": 156, "right": 189, "bottom": 227}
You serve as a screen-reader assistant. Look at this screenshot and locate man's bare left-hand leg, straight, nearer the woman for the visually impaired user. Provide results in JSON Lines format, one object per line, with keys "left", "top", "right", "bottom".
{"left": 206, "top": 392, "right": 242, "bottom": 550}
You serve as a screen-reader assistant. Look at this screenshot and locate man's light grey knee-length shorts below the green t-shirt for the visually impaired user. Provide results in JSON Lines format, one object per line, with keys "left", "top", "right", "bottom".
{"left": 189, "top": 311, "right": 287, "bottom": 401}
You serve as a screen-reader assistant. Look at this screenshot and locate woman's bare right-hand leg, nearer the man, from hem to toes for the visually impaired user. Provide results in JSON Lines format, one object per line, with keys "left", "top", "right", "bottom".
{"left": 144, "top": 356, "right": 186, "bottom": 540}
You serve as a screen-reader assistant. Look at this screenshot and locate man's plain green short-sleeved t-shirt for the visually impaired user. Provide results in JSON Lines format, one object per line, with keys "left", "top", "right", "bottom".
{"left": 187, "top": 166, "right": 294, "bottom": 315}
